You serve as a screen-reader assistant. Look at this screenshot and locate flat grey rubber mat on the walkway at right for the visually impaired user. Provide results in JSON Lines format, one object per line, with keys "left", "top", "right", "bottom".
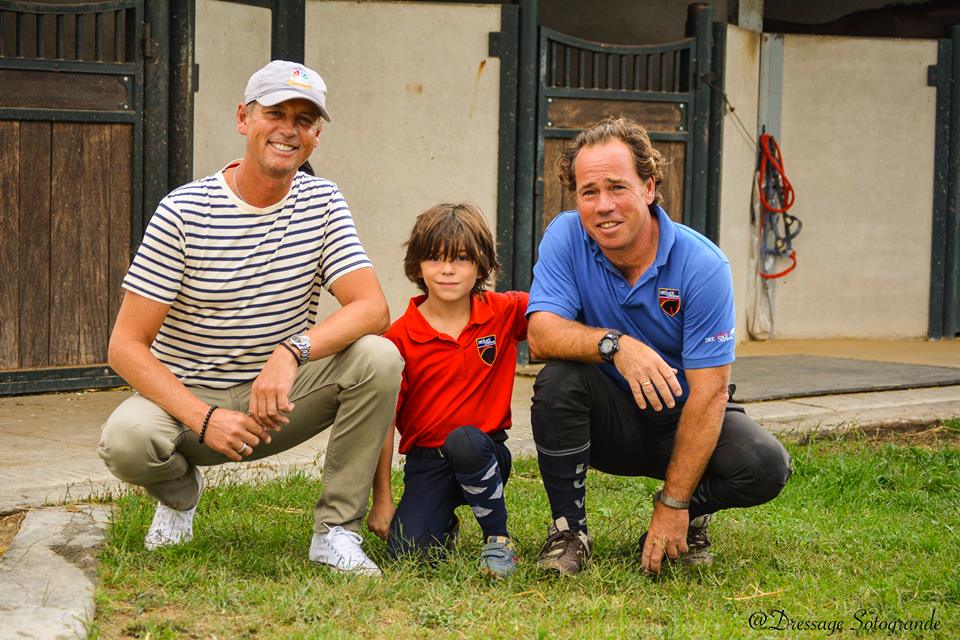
{"left": 730, "top": 356, "right": 960, "bottom": 402}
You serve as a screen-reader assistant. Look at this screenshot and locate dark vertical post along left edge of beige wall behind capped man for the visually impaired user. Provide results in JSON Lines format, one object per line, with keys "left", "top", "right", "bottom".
{"left": 168, "top": 0, "right": 195, "bottom": 189}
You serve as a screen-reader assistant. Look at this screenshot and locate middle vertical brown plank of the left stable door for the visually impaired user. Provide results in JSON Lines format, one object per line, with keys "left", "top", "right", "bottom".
{"left": 50, "top": 122, "right": 86, "bottom": 365}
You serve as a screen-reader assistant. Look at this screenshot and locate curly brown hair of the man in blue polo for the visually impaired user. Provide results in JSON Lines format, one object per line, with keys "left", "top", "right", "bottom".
{"left": 557, "top": 116, "right": 667, "bottom": 204}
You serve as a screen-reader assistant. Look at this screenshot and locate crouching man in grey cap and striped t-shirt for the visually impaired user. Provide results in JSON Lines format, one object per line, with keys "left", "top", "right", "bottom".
{"left": 99, "top": 60, "right": 403, "bottom": 575}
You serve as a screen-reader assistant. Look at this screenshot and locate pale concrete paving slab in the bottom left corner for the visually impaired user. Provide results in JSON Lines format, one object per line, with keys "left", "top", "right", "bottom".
{"left": 0, "top": 505, "right": 109, "bottom": 640}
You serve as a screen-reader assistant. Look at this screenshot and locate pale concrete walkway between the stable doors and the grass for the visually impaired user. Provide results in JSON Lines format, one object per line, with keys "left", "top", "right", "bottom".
{"left": 0, "top": 340, "right": 960, "bottom": 640}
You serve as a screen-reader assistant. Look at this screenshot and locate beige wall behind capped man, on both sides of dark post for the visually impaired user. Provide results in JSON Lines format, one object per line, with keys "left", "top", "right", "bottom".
{"left": 194, "top": 0, "right": 500, "bottom": 317}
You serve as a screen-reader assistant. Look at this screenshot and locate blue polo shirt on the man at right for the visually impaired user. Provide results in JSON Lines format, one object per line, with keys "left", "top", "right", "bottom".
{"left": 527, "top": 205, "right": 736, "bottom": 400}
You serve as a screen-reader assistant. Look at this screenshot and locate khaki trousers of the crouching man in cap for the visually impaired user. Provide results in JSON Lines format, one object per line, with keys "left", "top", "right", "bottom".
{"left": 97, "top": 336, "right": 403, "bottom": 533}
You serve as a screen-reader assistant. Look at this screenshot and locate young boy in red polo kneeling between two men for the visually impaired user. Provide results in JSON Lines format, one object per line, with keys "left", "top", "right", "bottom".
{"left": 367, "top": 204, "right": 528, "bottom": 578}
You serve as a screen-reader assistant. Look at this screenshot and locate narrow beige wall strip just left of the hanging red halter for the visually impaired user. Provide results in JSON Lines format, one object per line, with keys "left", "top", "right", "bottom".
{"left": 720, "top": 25, "right": 760, "bottom": 343}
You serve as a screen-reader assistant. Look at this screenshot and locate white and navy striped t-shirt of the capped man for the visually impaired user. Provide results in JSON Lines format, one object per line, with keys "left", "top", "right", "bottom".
{"left": 123, "top": 162, "right": 372, "bottom": 389}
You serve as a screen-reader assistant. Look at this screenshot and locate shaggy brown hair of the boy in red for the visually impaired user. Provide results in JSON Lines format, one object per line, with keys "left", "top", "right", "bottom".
{"left": 403, "top": 202, "right": 500, "bottom": 294}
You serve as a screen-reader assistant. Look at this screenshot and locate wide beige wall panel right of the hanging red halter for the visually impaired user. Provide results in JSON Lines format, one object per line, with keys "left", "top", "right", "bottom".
{"left": 774, "top": 35, "right": 936, "bottom": 338}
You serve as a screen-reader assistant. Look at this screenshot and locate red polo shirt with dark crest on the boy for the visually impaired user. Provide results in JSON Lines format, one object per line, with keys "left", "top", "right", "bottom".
{"left": 386, "top": 291, "right": 529, "bottom": 453}
